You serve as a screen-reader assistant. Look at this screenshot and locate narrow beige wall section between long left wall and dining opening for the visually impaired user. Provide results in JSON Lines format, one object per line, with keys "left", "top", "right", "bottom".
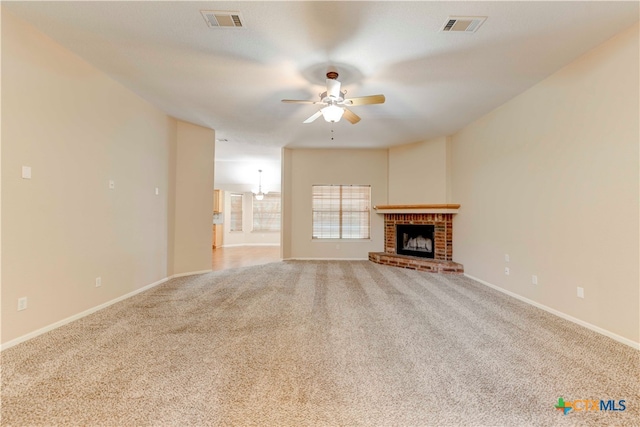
{"left": 173, "top": 121, "right": 215, "bottom": 274}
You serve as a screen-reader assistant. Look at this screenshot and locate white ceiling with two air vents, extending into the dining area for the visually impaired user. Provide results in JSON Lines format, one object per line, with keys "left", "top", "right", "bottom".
{"left": 2, "top": 1, "right": 639, "bottom": 189}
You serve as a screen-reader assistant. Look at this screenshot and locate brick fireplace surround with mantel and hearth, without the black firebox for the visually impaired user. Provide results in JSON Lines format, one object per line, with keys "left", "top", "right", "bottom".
{"left": 369, "top": 205, "right": 464, "bottom": 273}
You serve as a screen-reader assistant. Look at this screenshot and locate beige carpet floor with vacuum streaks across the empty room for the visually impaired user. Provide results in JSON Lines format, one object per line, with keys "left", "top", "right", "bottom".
{"left": 1, "top": 261, "right": 640, "bottom": 426}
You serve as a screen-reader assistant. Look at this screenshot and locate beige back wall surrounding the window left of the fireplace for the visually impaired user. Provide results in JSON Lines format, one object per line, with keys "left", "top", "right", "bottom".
{"left": 282, "top": 149, "right": 388, "bottom": 259}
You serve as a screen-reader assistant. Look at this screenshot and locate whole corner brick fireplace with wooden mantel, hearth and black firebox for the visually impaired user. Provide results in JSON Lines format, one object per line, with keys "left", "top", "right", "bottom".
{"left": 369, "top": 204, "right": 464, "bottom": 273}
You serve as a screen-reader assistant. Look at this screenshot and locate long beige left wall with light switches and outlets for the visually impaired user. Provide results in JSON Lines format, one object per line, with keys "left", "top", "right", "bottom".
{"left": 1, "top": 10, "right": 176, "bottom": 343}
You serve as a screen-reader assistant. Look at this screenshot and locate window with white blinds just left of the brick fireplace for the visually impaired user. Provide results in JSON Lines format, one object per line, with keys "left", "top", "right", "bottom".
{"left": 312, "top": 185, "right": 371, "bottom": 239}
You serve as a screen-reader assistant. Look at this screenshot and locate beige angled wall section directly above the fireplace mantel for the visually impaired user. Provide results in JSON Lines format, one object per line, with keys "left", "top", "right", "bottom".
{"left": 389, "top": 137, "right": 450, "bottom": 205}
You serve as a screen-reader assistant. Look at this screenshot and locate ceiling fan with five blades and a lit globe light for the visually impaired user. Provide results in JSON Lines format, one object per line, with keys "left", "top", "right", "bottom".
{"left": 282, "top": 71, "right": 384, "bottom": 125}
